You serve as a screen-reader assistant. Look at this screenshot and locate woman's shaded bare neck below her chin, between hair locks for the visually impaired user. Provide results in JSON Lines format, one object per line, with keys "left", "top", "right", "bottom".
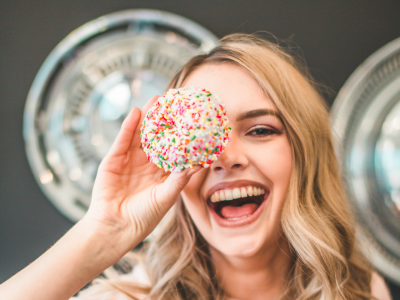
{"left": 210, "top": 238, "right": 291, "bottom": 300}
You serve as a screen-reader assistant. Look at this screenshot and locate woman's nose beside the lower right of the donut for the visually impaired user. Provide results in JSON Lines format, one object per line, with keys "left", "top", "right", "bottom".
{"left": 211, "top": 135, "right": 249, "bottom": 172}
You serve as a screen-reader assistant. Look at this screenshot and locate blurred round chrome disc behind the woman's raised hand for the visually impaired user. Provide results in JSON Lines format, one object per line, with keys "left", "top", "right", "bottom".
{"left": 23, "top": 10, "right": 218, "bottom": 221}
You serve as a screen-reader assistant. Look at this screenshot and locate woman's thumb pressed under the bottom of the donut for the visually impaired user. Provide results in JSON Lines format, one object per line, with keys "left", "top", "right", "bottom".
{"left": 157, "top": 165, "right": 202, "bottom": 206}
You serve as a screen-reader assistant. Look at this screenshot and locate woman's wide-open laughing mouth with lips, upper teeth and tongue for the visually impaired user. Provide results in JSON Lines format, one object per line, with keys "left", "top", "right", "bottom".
{"left": 207, "top": 186, "right": 269, "bottom": 226}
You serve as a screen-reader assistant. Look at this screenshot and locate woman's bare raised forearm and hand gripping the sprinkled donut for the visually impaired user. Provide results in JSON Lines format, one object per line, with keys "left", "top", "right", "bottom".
{"left": 0, "top": 97, "right": 200, "bottom": 300}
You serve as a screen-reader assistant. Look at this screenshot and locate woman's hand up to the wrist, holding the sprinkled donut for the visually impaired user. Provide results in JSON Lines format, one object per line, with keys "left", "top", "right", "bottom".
{"left": 84, "top": 96, "right": 200, "bottom": 248}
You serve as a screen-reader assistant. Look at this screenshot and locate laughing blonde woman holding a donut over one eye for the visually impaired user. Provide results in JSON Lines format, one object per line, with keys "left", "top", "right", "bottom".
{"left": 0, "top": 34, "right": 390, "bottom": 300}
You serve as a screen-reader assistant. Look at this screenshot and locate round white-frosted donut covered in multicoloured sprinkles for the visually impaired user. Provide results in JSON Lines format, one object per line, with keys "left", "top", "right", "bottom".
{"left": 140, "top": 87, "right": 231, "bottom": 172}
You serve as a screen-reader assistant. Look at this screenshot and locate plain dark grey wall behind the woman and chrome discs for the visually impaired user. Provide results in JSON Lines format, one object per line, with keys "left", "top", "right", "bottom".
{"left": 0, "top": 0, "right": 400, "bottom": 299}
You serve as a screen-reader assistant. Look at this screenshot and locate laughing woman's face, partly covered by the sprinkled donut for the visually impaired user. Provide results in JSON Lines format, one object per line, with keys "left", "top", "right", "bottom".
{"left": 182, "top": 63, "right": 292, "bottom": 257}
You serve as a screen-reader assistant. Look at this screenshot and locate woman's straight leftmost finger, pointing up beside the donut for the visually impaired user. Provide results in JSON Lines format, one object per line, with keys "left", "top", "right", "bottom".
{"left": 108, "top": 107, "right": 140, "bottom": 156}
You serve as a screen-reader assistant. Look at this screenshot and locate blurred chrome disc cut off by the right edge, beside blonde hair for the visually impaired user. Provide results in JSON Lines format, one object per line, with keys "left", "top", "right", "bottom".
{"left": 331, "top": 39, "right": 400, "bottom": 283}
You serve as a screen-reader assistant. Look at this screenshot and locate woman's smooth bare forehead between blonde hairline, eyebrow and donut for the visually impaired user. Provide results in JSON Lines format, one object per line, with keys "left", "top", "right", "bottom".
{"left": 182, "top": 63, "right": 275, "bottom": 118}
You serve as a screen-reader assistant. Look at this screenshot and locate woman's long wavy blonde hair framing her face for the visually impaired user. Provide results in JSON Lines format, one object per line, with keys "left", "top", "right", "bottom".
{"left": 79, "top": 34, "right": 373, "bottom": 300}
